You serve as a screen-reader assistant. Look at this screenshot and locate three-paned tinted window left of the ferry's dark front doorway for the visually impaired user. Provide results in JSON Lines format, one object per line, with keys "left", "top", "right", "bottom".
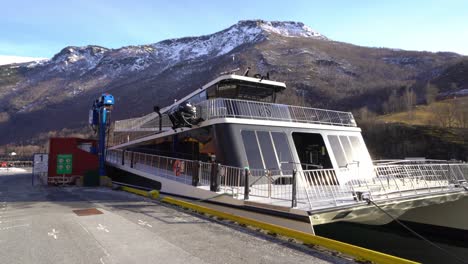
{"left": 241, "top": 130, "right": 293, "bottom": 170}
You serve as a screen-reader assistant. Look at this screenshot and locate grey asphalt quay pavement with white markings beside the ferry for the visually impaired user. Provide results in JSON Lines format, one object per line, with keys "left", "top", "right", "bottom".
{"left": 0, "top": 172, "right": 349, "bottom": 264}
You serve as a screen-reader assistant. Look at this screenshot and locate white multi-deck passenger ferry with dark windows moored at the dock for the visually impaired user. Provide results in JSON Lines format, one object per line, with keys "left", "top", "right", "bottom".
{"left": 106, "top": 71, "right": 468, "bottom": 230}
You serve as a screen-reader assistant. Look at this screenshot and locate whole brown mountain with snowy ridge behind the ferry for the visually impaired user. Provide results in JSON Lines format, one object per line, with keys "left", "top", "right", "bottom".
{"left": 0, "top": 20, "right": 467, "bottom": 145}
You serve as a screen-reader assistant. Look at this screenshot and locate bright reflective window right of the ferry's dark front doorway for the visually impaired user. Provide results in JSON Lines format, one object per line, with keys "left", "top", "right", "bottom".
{"left": 328, "top": 135, "right": 367, "bottom": 168}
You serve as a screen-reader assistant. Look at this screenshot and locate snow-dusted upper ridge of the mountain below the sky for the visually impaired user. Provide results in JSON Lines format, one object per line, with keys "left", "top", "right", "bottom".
{"left": 28, "top": 20, "right": 327, "bottom": 76}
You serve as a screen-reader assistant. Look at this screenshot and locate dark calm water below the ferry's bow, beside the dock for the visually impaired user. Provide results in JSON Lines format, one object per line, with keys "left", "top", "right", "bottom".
{"left": 315, "top": 223, "right": 468, "bottom": 264}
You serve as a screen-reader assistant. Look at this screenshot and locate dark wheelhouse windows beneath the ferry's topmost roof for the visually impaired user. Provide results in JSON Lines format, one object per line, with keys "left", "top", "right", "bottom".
{"left": 207, "top": 80, "right": 284, "bottom": 103}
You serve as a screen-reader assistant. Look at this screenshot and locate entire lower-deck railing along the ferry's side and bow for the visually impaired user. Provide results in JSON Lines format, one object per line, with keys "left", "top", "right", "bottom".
{"left": 106, "top": 150, "right": 468, "bottom": 210}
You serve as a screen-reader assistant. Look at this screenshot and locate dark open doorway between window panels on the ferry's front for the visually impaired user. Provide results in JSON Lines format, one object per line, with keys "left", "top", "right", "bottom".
{"left": 292, "top": 132, "right": 333, "bottom": 170}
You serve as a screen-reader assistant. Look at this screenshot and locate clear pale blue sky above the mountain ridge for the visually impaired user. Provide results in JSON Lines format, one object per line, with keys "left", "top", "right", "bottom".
{"left": 0, "top": 0, "right": 468, "bottom": 57}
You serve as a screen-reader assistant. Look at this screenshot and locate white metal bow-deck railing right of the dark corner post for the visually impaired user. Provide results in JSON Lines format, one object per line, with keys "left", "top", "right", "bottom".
{"left": 300, "top": 163, "right": 468, "bottom": 208}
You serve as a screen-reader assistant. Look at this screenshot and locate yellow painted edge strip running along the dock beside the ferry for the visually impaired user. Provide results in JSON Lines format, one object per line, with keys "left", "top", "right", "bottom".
{"left": 122, "top": 186, "right": 418, "bottom": 264}
